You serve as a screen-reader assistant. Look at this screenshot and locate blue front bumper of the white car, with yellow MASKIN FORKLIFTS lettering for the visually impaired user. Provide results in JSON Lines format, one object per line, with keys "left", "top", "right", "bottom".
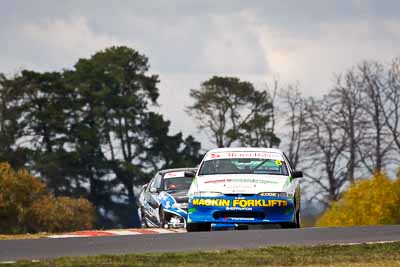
{"left": 187, "top": 195, "right": 296, "bottom": 224}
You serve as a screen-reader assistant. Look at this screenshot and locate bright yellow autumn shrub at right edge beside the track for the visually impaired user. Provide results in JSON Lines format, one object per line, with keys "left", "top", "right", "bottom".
{"left": 316, "top": 173, "right": 400, "bottom": 226}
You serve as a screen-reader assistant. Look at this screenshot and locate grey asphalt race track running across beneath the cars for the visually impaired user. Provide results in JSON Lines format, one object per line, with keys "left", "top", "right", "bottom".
{"left": 0, "top": 225, "right": 400, "bottom": 262}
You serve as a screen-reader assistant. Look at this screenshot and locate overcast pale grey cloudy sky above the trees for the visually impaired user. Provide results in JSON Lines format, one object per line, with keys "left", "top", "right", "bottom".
{"left": 0, "top": 0, "right": 400, "bottom": 149}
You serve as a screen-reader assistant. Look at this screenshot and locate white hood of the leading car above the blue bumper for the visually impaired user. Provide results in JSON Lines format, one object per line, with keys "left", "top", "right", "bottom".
{"left": 194, "top": 174, "right": 289, "bottom": 194}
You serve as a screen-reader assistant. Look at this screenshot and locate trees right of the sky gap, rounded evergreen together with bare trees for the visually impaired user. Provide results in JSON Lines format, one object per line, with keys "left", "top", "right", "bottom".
{"left": 187, "top": 59, "right": 400, "bottom": 209}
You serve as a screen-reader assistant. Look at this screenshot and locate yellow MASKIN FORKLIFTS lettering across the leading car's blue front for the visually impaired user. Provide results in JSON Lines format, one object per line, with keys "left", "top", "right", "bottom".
{"left": 192, "top": 198, "right": 288, "bottom": 208}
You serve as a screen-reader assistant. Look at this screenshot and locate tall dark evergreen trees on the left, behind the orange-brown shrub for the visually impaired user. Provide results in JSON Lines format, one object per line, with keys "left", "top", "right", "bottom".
{"left": 0, "top": 47, "right": 201, "bottom": 230}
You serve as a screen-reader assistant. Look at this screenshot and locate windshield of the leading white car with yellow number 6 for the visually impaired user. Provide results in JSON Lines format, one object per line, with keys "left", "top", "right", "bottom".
{"left": 199, "top": 158, "right": 288, "bottom": 175}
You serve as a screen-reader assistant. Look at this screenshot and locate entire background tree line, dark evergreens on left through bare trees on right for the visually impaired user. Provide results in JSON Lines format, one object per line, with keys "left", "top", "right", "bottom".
{"left": 0, "top": 43, "right": 400, "bottom": 227}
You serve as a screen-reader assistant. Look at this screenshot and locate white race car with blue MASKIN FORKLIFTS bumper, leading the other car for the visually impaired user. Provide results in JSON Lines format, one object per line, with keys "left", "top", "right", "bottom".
{"left": 187, "top": 148, "right": 303, "bottom": 232}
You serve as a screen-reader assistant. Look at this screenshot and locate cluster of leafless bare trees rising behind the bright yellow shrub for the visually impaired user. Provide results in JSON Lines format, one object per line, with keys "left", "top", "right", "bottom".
{"left": 274, "top": 58, "right": 400, "bottom": 205}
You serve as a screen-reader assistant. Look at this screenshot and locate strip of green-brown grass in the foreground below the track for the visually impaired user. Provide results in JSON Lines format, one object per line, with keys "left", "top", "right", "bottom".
{"left": 7, "top": 242, "right": 400, "bottom": 267}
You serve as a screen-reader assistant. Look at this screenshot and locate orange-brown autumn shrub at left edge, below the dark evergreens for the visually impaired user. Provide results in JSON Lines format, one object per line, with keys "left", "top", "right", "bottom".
{"left": 0, "top": 163, "right": 95, "bottom": 233}
